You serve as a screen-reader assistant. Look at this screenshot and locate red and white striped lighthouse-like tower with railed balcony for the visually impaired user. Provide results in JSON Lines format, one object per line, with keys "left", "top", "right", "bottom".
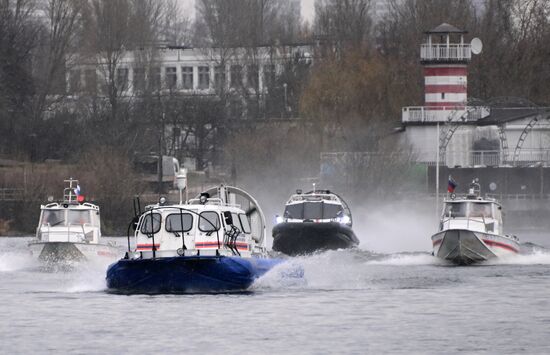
{"left": 420, "top": 23, "right": 472, "bottom": 110}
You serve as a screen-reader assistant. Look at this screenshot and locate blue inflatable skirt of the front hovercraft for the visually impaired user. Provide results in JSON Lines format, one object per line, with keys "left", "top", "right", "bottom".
{"left": 106, "top": 256, "right": 282, "bottom": 294}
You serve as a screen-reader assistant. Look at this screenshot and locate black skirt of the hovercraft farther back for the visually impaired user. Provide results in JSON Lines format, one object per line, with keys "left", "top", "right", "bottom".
{"left": 273, "top": 222, "right": 359, "bottom": 255}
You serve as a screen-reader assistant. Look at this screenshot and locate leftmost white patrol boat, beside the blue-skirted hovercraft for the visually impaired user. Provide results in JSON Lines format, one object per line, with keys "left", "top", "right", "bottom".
{"left": 28, "top": 178, "right": 118, "bottom": 263}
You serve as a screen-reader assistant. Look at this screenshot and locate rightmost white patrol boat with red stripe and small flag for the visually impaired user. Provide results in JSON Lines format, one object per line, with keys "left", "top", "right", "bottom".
{"left": 432, "top": 179, "right": 520, "bottom": 265}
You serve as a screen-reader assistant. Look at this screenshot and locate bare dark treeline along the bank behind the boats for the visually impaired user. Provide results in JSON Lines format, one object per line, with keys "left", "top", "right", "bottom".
{"left": 0, "top": 0, "right": 550, "bottom": 231}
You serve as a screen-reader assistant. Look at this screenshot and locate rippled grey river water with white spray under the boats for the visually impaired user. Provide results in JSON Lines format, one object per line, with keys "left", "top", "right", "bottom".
{"left": 0, "top": 237, "right": 550, "bottom": 354}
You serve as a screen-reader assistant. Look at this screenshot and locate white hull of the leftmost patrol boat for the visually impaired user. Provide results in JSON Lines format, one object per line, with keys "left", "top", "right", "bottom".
{"left": 29, "top": 242, "right": 119, "bottom": 263}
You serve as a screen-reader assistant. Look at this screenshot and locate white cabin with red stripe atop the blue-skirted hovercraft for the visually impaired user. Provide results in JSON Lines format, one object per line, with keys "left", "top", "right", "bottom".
{"left": 132, "top": 198, "right": 265, "bottom": 258}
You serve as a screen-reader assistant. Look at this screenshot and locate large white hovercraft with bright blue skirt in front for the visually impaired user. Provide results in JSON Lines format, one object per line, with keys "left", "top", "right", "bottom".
{"left": 106, "top": 185, "right": 280, "bottom": 294}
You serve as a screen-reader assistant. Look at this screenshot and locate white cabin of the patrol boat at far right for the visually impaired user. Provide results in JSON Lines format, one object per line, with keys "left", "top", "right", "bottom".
{"left": 440, "top": 198, "right": 503, "bottom": 235}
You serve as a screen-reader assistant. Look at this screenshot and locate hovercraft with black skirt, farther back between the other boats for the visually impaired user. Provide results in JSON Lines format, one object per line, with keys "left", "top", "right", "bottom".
{"left": 272, "top": 190, "right": 359, "bottom": 255}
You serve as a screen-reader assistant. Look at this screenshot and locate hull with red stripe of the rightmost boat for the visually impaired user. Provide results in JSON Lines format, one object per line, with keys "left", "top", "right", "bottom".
{"left": 432, "top": 229, "right": 520, "bottom": 265}
